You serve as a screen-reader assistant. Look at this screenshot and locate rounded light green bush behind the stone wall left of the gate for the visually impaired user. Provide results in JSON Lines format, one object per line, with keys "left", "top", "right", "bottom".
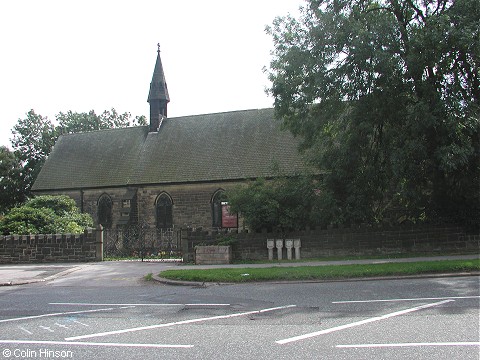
{"left": 0, "top": 195, "right": 93, "bottom": 235}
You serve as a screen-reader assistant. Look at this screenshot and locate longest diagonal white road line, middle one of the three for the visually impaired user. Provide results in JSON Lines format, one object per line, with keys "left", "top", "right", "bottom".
{"left": 65, "top": 305, "right": 296, "bottom": 341}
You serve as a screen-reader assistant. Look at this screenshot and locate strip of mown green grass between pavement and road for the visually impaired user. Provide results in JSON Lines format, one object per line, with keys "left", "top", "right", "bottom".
{"left": 159, "top": 259, "right": 480, "bottom": 283}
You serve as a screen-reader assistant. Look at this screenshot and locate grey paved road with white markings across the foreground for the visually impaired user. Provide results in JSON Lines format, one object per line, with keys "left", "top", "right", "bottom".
{"left": 0, "top": 263, "right": 480, "bottom": 360}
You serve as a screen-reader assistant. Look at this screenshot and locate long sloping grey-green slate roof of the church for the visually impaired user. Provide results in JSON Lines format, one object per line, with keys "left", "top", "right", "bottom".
{"left": 33, "top": 109, "right": 303, "bottom": 191}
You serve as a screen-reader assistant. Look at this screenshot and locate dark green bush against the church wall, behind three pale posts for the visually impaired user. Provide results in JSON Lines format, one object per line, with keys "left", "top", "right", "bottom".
{"left": 226, "top": 176, "right": 315, "bottom": 232}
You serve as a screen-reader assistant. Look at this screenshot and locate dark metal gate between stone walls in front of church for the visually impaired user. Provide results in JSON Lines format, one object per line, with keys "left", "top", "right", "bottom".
{"left": 103, "top": 225, "right": 182, "bottom": 261}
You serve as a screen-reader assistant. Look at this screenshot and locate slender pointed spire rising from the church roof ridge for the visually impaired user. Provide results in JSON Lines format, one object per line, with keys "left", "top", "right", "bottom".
{"left": 147, "top": 44, "right": 170, "bottom": 131}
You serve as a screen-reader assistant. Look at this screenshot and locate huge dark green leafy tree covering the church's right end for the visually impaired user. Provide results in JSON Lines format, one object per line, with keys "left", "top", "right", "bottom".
{"left": 267, "top": 0, "right": 480, "bottom": 222}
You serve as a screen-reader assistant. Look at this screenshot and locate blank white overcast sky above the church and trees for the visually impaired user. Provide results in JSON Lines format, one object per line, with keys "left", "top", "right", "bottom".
{"left": 0, "top": 0, "right": 304, "bottom": 145}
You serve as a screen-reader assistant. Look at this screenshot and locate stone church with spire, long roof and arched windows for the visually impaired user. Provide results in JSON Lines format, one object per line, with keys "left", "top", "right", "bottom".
{"left": 33, "top": 47, "right": 303, "bottom": 229}
